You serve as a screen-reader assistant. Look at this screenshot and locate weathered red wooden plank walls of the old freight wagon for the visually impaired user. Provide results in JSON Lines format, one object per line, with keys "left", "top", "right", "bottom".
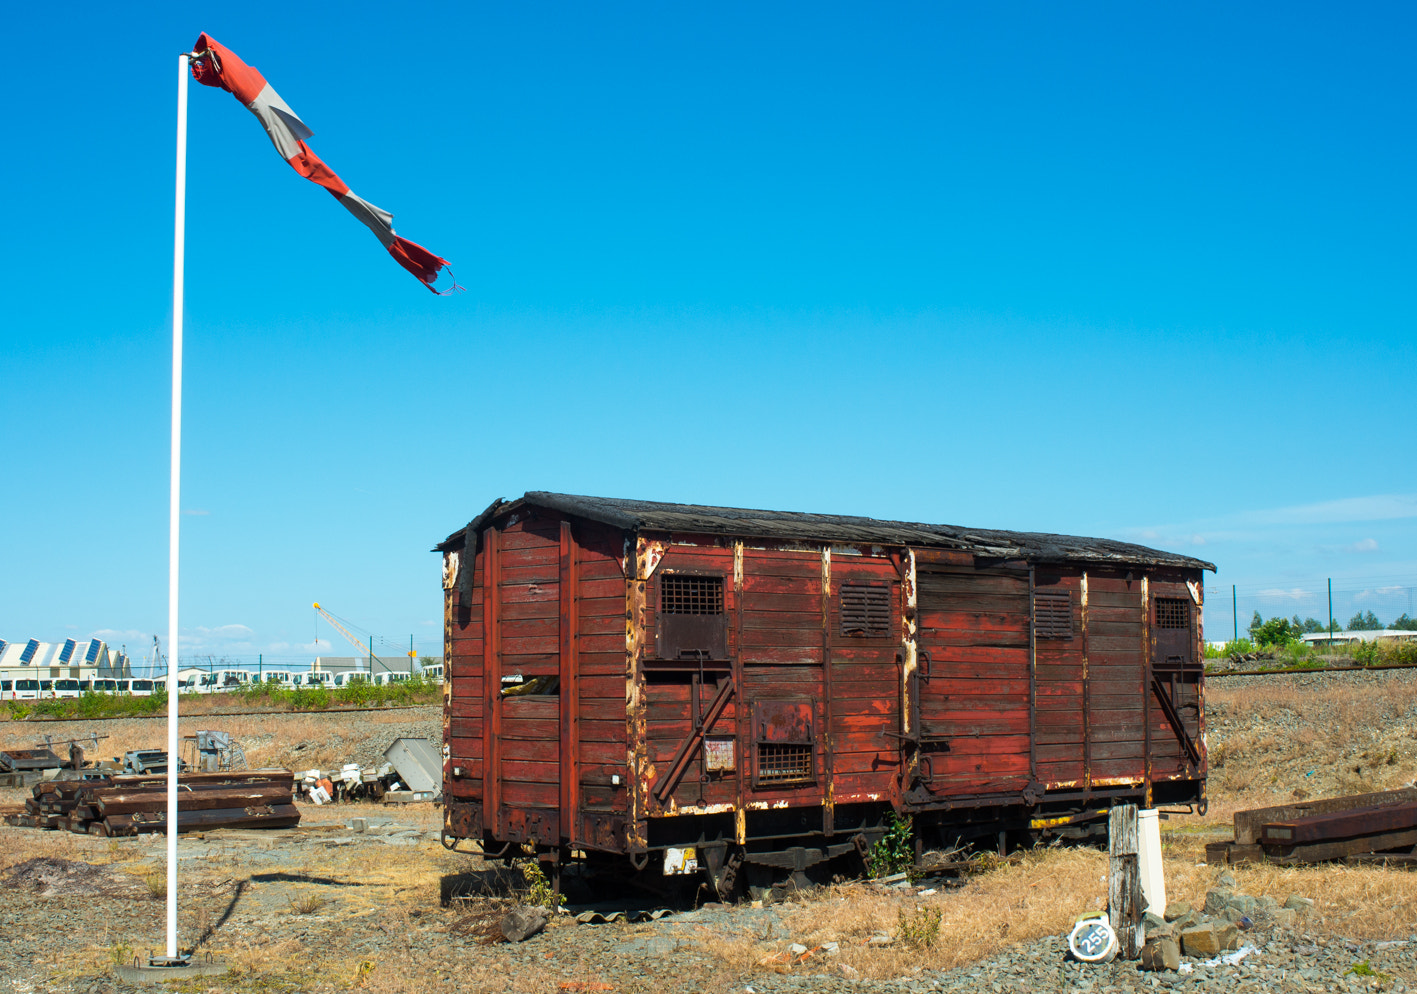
{"left": 445, "top": 506, "right": 1204, "bottom": 852}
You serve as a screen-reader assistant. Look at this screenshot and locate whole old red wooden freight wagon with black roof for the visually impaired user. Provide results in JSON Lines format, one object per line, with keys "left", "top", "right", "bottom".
{"left": 438, "top": 493, "right": 1214, "bottom": 896}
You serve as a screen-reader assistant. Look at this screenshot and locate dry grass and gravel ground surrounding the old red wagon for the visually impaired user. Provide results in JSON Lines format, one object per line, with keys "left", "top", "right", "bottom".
{"left": 0, "top": 674, "right": 1417, "bottom": 994}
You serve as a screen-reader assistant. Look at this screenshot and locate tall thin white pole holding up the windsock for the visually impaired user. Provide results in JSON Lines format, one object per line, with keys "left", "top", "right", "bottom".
{"left": 167, "top": 54, "right": 188, "bottom": 960}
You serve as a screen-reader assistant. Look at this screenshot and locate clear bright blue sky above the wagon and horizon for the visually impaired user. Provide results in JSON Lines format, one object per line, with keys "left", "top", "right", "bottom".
{"left": 0, "top": 3, "right": 1417, "bottom": 659}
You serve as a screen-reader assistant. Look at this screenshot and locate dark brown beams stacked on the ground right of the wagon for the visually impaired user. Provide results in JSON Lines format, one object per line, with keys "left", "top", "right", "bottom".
{"left": 1206, "top": 787, "right": 1417, "bottom": 866}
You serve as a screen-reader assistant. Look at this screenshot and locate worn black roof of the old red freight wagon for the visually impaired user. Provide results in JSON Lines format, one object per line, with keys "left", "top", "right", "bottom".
{"left": 438, "top": 491, "right": 1216, "bottom": 571}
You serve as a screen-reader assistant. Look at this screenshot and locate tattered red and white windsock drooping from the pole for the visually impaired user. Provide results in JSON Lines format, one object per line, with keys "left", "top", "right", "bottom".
{"left": 191, "top": 31, "right": 448, "bottom": 294}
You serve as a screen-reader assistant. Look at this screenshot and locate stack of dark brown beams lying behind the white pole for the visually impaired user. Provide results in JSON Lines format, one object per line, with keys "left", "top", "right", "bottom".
{"left": 6, "top": 770, "right": 300, "bottom": 837}
